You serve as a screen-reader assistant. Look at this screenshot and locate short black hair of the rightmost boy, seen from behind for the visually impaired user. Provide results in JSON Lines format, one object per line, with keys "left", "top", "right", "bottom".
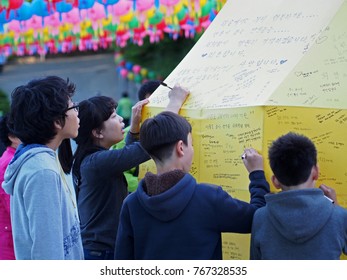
{"left": 269, "top": 132, "right": 317, "bottom": 186}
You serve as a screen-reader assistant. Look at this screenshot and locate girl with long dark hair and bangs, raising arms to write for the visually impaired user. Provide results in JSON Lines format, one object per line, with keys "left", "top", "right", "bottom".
{"left": 68, "top": 86, "right": 188, "bottom": 260}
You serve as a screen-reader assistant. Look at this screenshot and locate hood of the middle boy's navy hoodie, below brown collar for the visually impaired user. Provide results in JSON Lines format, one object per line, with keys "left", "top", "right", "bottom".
{"left": 136, "top": 174, "right": 196, "bottom": 222}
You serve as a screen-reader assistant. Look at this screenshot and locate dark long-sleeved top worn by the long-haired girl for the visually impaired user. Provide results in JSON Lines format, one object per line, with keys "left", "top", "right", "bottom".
{"left": 74, "top": 133, "right": 150, "bottom": 251}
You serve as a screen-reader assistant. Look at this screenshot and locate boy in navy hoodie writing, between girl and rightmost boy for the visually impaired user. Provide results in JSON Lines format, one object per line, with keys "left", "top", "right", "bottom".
{"left": 115, "top": 112, "right": 269, "bottom": 260}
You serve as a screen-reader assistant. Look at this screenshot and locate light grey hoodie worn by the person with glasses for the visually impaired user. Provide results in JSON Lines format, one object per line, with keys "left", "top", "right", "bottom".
{"left": 2, "top": 145, "right": 84, "bottom": 260}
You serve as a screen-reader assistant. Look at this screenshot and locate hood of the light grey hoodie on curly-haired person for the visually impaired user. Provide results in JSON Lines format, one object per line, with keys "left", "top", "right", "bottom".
{"left": 2, "top": 144, "right": 55, "bottom": 195}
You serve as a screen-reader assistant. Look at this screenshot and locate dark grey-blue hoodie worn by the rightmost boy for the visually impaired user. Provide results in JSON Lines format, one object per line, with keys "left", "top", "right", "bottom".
{"left": 251, "top": 188, "right": 347, "bottom": 260}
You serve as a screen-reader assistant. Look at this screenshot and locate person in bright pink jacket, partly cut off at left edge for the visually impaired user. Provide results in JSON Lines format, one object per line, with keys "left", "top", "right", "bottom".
{"left": 0, "top": 116, "right": 21, "bottom": 260}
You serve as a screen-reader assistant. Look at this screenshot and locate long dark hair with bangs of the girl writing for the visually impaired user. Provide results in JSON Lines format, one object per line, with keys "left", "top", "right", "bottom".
{"left": 72, "top": 96, "right": 117, "bottom": 185}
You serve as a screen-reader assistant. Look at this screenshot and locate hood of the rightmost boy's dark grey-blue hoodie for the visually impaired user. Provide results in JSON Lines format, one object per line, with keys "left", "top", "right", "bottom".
{"left": 265, "top": 188, "right": 334, "bottom": 243}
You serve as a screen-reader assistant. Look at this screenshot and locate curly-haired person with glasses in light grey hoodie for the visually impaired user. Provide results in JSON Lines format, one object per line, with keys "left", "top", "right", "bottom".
{"left": 2, "top": 76, "right": 84, "bottom": 260}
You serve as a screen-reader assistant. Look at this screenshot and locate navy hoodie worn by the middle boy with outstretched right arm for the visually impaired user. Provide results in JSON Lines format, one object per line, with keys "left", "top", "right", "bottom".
{"left": 115, "top": 171, "right": 269, "bottom": 260}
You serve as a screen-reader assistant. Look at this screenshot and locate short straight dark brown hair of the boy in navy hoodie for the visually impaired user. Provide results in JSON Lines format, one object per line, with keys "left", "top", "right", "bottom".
{"left": 140, "top": 111, "right": 192, "bottom": 161}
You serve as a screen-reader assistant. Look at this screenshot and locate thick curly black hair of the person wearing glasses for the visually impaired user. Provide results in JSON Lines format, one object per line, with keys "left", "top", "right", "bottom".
{"left": 8, "top": 76, "right": 75, "bottom": 145}
